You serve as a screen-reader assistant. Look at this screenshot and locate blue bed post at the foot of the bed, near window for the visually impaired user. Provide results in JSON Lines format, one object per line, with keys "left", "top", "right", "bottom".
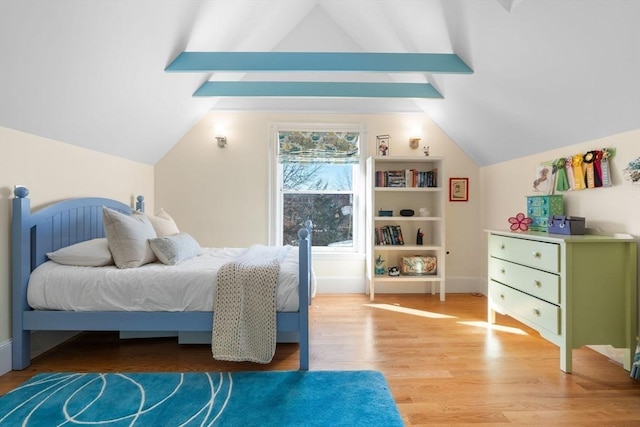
{"left": 298, "top": 220, "right": 313, "bottom": 371}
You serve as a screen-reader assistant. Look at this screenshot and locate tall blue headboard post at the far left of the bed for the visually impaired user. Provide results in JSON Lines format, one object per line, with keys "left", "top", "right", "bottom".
{"left": 11, "top": 187, "right": 31, "bottom": 370}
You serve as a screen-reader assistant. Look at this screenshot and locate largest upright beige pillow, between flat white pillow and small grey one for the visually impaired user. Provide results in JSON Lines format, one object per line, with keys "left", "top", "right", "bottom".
{"left": 102, "top": 207, "right": 157, "bottom": 268}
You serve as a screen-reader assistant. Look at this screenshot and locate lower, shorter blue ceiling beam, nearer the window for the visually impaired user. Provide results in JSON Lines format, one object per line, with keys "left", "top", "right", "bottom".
{"left": 193, "top": 81, "right": 442, "bottom": 98}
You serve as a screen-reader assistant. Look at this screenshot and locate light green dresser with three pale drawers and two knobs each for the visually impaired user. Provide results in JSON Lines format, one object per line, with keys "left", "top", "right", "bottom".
{"left": 488, "top": 230, "right": 637, "bottom": 372}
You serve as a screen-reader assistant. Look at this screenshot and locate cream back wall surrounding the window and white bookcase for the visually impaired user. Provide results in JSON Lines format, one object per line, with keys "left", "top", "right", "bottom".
{"left": 155, "top": 112, "right": 480, "bottom": 292}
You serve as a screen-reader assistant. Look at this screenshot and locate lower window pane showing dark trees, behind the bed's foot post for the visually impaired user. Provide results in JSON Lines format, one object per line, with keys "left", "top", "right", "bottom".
{"left": 282, "top": 194, "right": 353, "bottom": 248}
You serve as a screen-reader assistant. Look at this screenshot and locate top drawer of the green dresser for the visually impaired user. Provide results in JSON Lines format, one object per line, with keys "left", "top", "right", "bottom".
{"left": 489, "top": 234, "right": 560, "bottom": 272}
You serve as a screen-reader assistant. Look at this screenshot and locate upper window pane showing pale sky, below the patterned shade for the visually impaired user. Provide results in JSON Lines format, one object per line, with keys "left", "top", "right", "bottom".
{"left": 282, "top": 163, "right": 353, "bottom": 191}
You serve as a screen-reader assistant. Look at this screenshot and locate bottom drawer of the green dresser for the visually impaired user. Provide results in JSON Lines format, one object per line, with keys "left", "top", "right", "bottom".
{"left": 489, "top": 280, "right": 560, "bottom": 335}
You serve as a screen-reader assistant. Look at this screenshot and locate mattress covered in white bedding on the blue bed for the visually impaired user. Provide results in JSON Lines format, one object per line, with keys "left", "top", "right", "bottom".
{"left": 27, "top": 247, "right": 308, "bottom": 312}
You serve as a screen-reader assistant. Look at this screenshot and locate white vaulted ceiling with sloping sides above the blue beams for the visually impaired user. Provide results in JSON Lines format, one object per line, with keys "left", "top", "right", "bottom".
{"left": 0, "top": 0, "right": 640, "bottom": 165}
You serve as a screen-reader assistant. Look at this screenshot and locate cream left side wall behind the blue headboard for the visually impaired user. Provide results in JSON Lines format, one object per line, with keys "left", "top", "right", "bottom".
{"left": 0, "top": 127, "right": 154, "bottom": 373}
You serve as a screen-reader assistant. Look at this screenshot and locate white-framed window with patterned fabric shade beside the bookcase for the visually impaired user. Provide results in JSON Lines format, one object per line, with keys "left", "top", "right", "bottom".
{"left": 273, "top": 126, "right": 362, "bottom": 252}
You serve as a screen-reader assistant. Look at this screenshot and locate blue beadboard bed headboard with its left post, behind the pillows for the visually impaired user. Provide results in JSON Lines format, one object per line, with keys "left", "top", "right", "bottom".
{"left": 11, "top": 187, "right": 144, "bottom": 310}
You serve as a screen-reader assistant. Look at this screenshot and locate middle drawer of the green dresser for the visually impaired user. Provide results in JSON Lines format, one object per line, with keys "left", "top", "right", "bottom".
{"left": 489, "top": 258, "right": 560, "bottom": 305}
